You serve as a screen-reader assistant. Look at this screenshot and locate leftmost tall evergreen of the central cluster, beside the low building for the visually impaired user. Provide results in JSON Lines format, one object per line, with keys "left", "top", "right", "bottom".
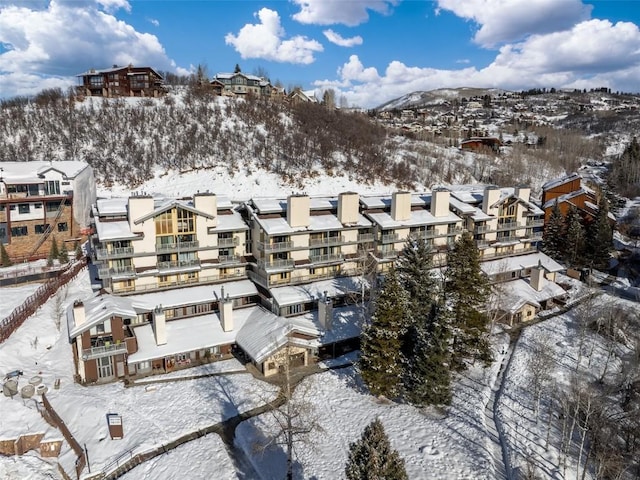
{"left": 358, "top": 269, "right": 409, "bottom": 397}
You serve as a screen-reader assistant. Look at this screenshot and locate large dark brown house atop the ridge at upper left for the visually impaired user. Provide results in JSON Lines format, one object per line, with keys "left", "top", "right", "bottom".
{"left": 76, "top": 65, "right": 166, "bottom": 98}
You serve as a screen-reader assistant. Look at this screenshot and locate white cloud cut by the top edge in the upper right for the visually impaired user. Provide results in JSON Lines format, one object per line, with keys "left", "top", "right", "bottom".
{"left": 436, "top": 0, "right": 592, "bottom": 47}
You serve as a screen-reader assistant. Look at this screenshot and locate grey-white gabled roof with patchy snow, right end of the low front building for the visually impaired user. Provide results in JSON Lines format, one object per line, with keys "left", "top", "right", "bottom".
{"left": 236, "top": 307, "right": 320, "bottom": 363}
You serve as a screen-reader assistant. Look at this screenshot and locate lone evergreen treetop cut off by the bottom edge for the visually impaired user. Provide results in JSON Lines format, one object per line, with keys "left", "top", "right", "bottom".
{"left": 345, "top": 419, "right": 409, "bottom": 480}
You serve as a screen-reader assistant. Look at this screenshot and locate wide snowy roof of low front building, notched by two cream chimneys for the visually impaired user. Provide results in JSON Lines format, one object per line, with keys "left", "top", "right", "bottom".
{"left": 127, "top": 307, "right": 251, "bottom": 364}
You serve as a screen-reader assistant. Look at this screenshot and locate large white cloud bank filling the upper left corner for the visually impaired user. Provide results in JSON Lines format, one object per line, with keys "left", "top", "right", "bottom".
{"left": 0, "top": 0, "right": 185, "bottom": 96}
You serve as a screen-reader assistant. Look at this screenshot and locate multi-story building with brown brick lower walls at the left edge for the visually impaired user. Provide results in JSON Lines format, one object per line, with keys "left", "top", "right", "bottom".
{"left": 0, "top": 161, "right": 96, "bottom": 261}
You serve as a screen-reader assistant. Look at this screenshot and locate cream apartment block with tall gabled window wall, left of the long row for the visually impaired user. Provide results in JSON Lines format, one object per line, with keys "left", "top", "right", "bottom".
{"left": 92, "top": 193, "right": 249, "bottom": 294}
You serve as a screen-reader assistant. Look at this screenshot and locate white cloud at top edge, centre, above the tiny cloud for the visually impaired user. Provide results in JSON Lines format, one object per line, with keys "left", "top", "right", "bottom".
{"left": 291, "top": 0, "right": 400, "bottom": 27}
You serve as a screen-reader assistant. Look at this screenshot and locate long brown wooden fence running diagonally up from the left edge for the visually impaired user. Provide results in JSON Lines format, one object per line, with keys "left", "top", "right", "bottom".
{"left": 0, "top": 257, "right": 87, "bottom": 343}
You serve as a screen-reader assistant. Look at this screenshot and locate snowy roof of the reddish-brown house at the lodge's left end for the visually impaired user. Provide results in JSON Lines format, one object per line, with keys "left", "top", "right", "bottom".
{"left": 67, "top": 294, "right": 138, "bottom": 339}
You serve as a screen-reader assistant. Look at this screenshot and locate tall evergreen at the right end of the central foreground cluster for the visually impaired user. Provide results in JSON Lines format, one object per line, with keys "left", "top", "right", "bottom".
{"left": 445, "top": 232, "right": 491, "bottom": 370}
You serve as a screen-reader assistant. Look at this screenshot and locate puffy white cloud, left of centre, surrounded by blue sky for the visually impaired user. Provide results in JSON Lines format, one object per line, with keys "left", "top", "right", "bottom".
{"left": 224, "top": 8, "right": 323, "bottom": 64}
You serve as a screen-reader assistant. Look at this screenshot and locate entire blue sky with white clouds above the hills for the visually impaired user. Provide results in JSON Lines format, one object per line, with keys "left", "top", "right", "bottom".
{"left": 0, "top": 0, "right": 640, "bottom": 107}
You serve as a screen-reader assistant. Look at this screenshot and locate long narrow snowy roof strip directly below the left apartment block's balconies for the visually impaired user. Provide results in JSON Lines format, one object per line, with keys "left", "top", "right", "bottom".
{"left": 127, "top": 280, "right": 258, "bottom": 311}
